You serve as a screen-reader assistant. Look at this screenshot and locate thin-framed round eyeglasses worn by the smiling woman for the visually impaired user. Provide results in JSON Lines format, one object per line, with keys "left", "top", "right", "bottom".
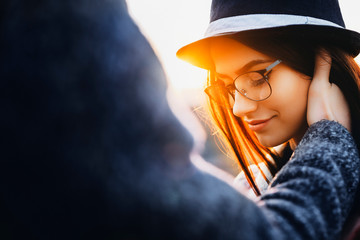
{"left": 205, "top": 60, "right": 281, "bottom": 107}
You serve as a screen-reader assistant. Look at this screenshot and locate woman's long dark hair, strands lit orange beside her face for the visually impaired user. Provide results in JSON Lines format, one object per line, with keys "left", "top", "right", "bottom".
{"left": 207, "top": 27, "right": 360, "bottom": 195}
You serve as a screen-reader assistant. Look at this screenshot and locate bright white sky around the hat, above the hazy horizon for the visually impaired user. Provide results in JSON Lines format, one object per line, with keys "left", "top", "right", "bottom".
{"left": 127, "top": 0, "right": 360, "bottom": 98}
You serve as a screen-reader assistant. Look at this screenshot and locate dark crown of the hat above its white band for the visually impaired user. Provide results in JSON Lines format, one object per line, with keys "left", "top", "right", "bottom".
{"left": 210, "top": 0, "right": 345, "bottom": 27}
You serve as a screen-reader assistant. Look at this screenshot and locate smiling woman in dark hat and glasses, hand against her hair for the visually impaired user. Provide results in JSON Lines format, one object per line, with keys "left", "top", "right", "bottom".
{"left": 177, "top": 0, "right": 360, "bottom": 236}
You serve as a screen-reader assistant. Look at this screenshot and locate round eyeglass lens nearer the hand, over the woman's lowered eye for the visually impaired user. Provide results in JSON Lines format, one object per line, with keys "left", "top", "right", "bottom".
{"left": 235, "top": 72, "right": 271, "bottom": 101}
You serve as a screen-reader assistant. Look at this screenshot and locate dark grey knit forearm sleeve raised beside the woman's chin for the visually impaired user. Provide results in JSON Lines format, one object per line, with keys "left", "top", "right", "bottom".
{"left": 258, "top": 120, "right": 360, "bottom": 240}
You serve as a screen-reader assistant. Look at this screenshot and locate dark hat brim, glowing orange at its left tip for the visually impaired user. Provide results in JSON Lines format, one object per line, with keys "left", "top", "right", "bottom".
{"left": 176, "top": 24, "right": 360, "bottom": 69}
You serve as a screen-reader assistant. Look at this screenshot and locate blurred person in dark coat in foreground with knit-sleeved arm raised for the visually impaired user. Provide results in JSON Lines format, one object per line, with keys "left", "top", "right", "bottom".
{"left": 0, "top": 0, "right": 359, "bottom": 239}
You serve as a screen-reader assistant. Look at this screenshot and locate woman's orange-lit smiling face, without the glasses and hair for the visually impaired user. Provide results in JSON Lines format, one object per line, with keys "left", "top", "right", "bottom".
{"left": 211, "top": 38, "right": 311, "bottom": 147}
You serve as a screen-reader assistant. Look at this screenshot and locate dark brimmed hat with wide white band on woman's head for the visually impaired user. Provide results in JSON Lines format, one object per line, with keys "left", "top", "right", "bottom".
{"left": 176, "top": 0, "right": 360, "bottom": 69}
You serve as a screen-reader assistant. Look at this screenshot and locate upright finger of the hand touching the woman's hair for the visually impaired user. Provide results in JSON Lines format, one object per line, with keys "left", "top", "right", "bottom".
{"left": 313, "top": 50, "right": 331, "bottom": 83}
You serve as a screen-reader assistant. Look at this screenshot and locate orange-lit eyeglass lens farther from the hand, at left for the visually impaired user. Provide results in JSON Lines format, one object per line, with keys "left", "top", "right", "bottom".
{"left": 205, "top": 85, "right": 235, "bottom": 108}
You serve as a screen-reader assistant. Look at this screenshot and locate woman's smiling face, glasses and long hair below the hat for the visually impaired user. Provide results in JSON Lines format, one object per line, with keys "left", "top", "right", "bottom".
{"left": 206, "top": 29, "right": 360, "bottom": 195}
